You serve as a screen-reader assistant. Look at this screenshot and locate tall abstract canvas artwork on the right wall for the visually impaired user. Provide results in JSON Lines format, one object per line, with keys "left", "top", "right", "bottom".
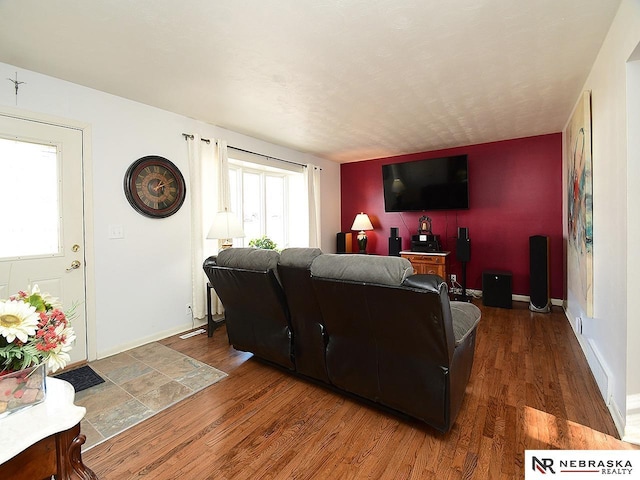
{"left": 563, "top": 91, "right": 593, "bottom": 317}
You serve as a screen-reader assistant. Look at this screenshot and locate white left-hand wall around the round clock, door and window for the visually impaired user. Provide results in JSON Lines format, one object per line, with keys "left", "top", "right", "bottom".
{"left": 0, "top": 63, "right": 340, "bottom": 358}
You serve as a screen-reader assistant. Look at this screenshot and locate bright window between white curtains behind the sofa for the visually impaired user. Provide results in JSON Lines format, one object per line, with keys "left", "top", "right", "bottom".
{"left": 228, "top": 148, "right": 309, "bottom": 249}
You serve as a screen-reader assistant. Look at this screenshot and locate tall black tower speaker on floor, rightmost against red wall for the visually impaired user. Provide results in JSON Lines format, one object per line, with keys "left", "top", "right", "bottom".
{"left": 529, "top": 235, "right": 551, "bottom": 313}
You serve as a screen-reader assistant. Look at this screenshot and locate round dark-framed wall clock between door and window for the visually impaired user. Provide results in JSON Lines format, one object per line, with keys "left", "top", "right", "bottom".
{"left": 124, "top": 155, "right": 187, "bottom": 218}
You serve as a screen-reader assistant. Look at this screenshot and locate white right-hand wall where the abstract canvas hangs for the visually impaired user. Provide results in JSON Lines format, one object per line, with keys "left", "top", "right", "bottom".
{"left": 565, "top": 0, "right": 640, "bottom": 441}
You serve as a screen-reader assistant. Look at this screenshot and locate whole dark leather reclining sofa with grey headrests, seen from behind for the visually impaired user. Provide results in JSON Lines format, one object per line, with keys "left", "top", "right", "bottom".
{"left": 203, "top": 248, "right": 480, "bottom": 432}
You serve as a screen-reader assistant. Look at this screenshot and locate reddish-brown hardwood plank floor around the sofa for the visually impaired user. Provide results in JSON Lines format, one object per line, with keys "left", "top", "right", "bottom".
{"left": 83, "top": 302, "right": 639, "bottom": 480}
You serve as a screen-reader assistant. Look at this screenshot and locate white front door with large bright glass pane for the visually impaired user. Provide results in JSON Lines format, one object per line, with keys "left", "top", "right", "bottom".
{"left": 0, "top": 114, "right": 87, "bottom": 364}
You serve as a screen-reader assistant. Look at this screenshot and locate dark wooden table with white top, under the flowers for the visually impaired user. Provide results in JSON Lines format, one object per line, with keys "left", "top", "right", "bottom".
{"left": 0, "top": 377, "right": 98, "bottom": 480}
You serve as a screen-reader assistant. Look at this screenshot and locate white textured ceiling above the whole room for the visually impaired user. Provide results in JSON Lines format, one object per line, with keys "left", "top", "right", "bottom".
{"left": 0, "top": 0, "right": 620, "bottom": 162}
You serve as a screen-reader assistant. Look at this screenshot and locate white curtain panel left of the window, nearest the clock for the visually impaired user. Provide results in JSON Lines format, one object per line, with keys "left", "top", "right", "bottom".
{"left": 187, "top": 135, "right": 217, "bottom": 319}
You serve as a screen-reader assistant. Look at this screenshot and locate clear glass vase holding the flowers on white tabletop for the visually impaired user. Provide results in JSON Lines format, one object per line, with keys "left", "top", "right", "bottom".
{"left": 0, "top": 363, "right": 47, "bottom": 418}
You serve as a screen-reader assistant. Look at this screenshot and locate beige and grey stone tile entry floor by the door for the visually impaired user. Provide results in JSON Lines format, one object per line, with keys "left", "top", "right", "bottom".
{"left": 74, "top": 342, "right": 227, "bottom": 450}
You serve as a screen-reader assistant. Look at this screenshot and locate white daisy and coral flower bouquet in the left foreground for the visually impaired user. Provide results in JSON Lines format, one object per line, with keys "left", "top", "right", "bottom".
{"left": 0, "top": 285, "right": 76, "bottom": 378}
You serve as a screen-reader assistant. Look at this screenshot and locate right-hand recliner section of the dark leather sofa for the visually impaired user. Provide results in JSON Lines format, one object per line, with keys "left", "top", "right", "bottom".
{"left": 311, "top": 254, "right": 480, "bottom": 431}
